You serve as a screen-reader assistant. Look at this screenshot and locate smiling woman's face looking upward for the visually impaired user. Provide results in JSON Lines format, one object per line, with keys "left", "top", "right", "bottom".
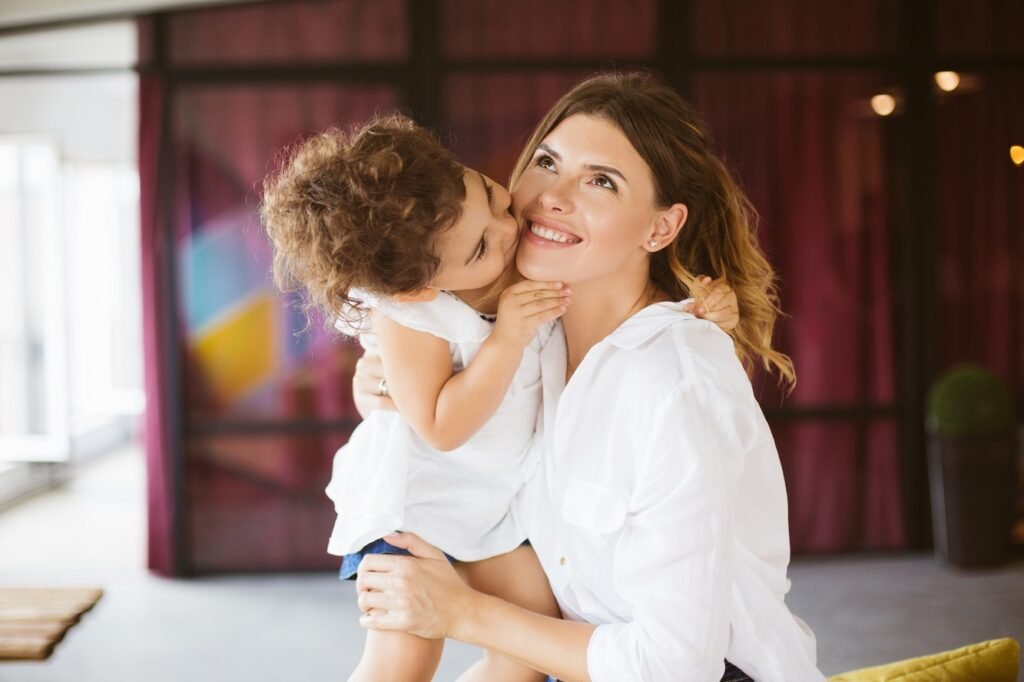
{"left": 512, "top": 115, "right": 662, "bottom": 285}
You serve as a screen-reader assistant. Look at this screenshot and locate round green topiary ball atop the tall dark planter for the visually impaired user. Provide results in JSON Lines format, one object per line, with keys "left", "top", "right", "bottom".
{"left": 928, "top": 365, "right": 1015, "bottom": 436}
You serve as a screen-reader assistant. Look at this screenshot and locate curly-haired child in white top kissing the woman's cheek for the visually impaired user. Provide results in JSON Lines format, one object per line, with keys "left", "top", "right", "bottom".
{"left": 262, "top": 116, "right": 734, "bottom": 681}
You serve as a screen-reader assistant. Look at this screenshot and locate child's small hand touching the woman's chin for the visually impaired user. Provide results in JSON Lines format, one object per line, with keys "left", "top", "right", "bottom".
{"left": 494, "top": 280, "right": 572, "bottom": 350}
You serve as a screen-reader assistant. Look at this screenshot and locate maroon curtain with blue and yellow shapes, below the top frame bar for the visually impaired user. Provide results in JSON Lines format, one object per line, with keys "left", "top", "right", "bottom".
{"left": 174, "top": 84, "right": 395, "bottom": 571}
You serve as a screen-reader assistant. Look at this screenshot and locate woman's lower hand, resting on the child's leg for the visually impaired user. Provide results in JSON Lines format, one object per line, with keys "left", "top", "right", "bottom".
{"left": 355, "top": 532, "right": 477, "bottom": 639}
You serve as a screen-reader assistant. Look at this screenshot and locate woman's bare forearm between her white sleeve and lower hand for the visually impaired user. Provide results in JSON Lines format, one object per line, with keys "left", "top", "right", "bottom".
{"left": 451, "top": 592, "right": 596, "bottom": 682}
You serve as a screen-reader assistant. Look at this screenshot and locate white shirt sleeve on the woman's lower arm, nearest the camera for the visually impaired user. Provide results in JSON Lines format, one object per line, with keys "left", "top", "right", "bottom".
{"left": 587, "top": 374, "right": 743, "bottom": 682}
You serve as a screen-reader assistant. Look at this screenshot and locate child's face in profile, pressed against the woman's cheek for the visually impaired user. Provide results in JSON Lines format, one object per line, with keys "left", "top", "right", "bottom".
{"left": 430, "top": 168, "right": 519, "bottom": 291}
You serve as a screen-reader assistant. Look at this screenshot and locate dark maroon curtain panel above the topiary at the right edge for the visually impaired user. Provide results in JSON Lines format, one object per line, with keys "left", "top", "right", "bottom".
{"left": 935, "top": 73, "right": 1024, "bottom": 393}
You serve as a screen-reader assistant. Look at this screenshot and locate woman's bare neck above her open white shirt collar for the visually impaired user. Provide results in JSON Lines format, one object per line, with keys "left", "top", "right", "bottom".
{"left": 562, "top": 273, "right": 670, "bottom": 381}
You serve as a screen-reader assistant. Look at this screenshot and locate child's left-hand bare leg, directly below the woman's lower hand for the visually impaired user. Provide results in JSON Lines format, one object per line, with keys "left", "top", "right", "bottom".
{"left": 348, "top": 630, "right": 444, "bottom": 682}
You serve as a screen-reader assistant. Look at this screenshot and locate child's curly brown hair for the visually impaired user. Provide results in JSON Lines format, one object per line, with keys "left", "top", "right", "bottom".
{"left": 260, "top": 114, "right": 466, "bottom": 325}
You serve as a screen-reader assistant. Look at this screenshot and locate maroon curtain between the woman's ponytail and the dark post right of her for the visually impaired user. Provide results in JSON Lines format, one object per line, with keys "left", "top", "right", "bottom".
{"left": 695, "top": 72, "right": 903, "bottom": 552}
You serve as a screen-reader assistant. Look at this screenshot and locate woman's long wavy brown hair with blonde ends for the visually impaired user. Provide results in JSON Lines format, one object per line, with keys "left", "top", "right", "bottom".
{"left": 509, "top": 73, "right": 796, "bottom": 385}
